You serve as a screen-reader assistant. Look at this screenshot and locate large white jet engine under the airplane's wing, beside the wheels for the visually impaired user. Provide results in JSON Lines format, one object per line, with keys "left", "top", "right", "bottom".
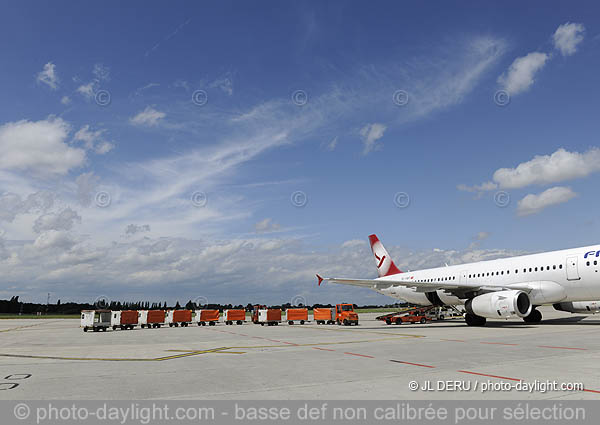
{"left": 465, "top": 290, "right": 532, "bottom": 319}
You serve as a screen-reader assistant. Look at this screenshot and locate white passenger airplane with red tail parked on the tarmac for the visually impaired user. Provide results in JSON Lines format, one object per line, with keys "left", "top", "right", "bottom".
{"left": 317, "top": 235, "right": 600, "bottom": 326}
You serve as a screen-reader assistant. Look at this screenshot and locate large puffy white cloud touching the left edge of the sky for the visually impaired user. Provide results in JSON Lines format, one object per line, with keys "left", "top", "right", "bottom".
{"left": 0, "top": 117, "right": 86, "bottom": 176}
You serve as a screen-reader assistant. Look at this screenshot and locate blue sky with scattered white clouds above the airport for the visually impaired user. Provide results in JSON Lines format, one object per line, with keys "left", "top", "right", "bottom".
{"left": 0, "top": 1, "right": 600, "bottom": 303}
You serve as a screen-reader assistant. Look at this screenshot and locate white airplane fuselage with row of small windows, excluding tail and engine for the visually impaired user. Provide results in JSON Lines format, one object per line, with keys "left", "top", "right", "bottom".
{"left": 377, "top": 245, "right": 600, "bottom": 305}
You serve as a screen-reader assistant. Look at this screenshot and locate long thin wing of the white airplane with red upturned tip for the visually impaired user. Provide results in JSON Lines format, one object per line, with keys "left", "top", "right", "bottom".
{"left": 317, "top": 274, "right": 533, "bottom": 293}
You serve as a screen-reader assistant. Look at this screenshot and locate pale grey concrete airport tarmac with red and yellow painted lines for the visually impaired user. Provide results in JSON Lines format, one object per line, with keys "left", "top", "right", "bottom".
{"left": 0, "top": 307, "right": 600, "bottom": 400}
